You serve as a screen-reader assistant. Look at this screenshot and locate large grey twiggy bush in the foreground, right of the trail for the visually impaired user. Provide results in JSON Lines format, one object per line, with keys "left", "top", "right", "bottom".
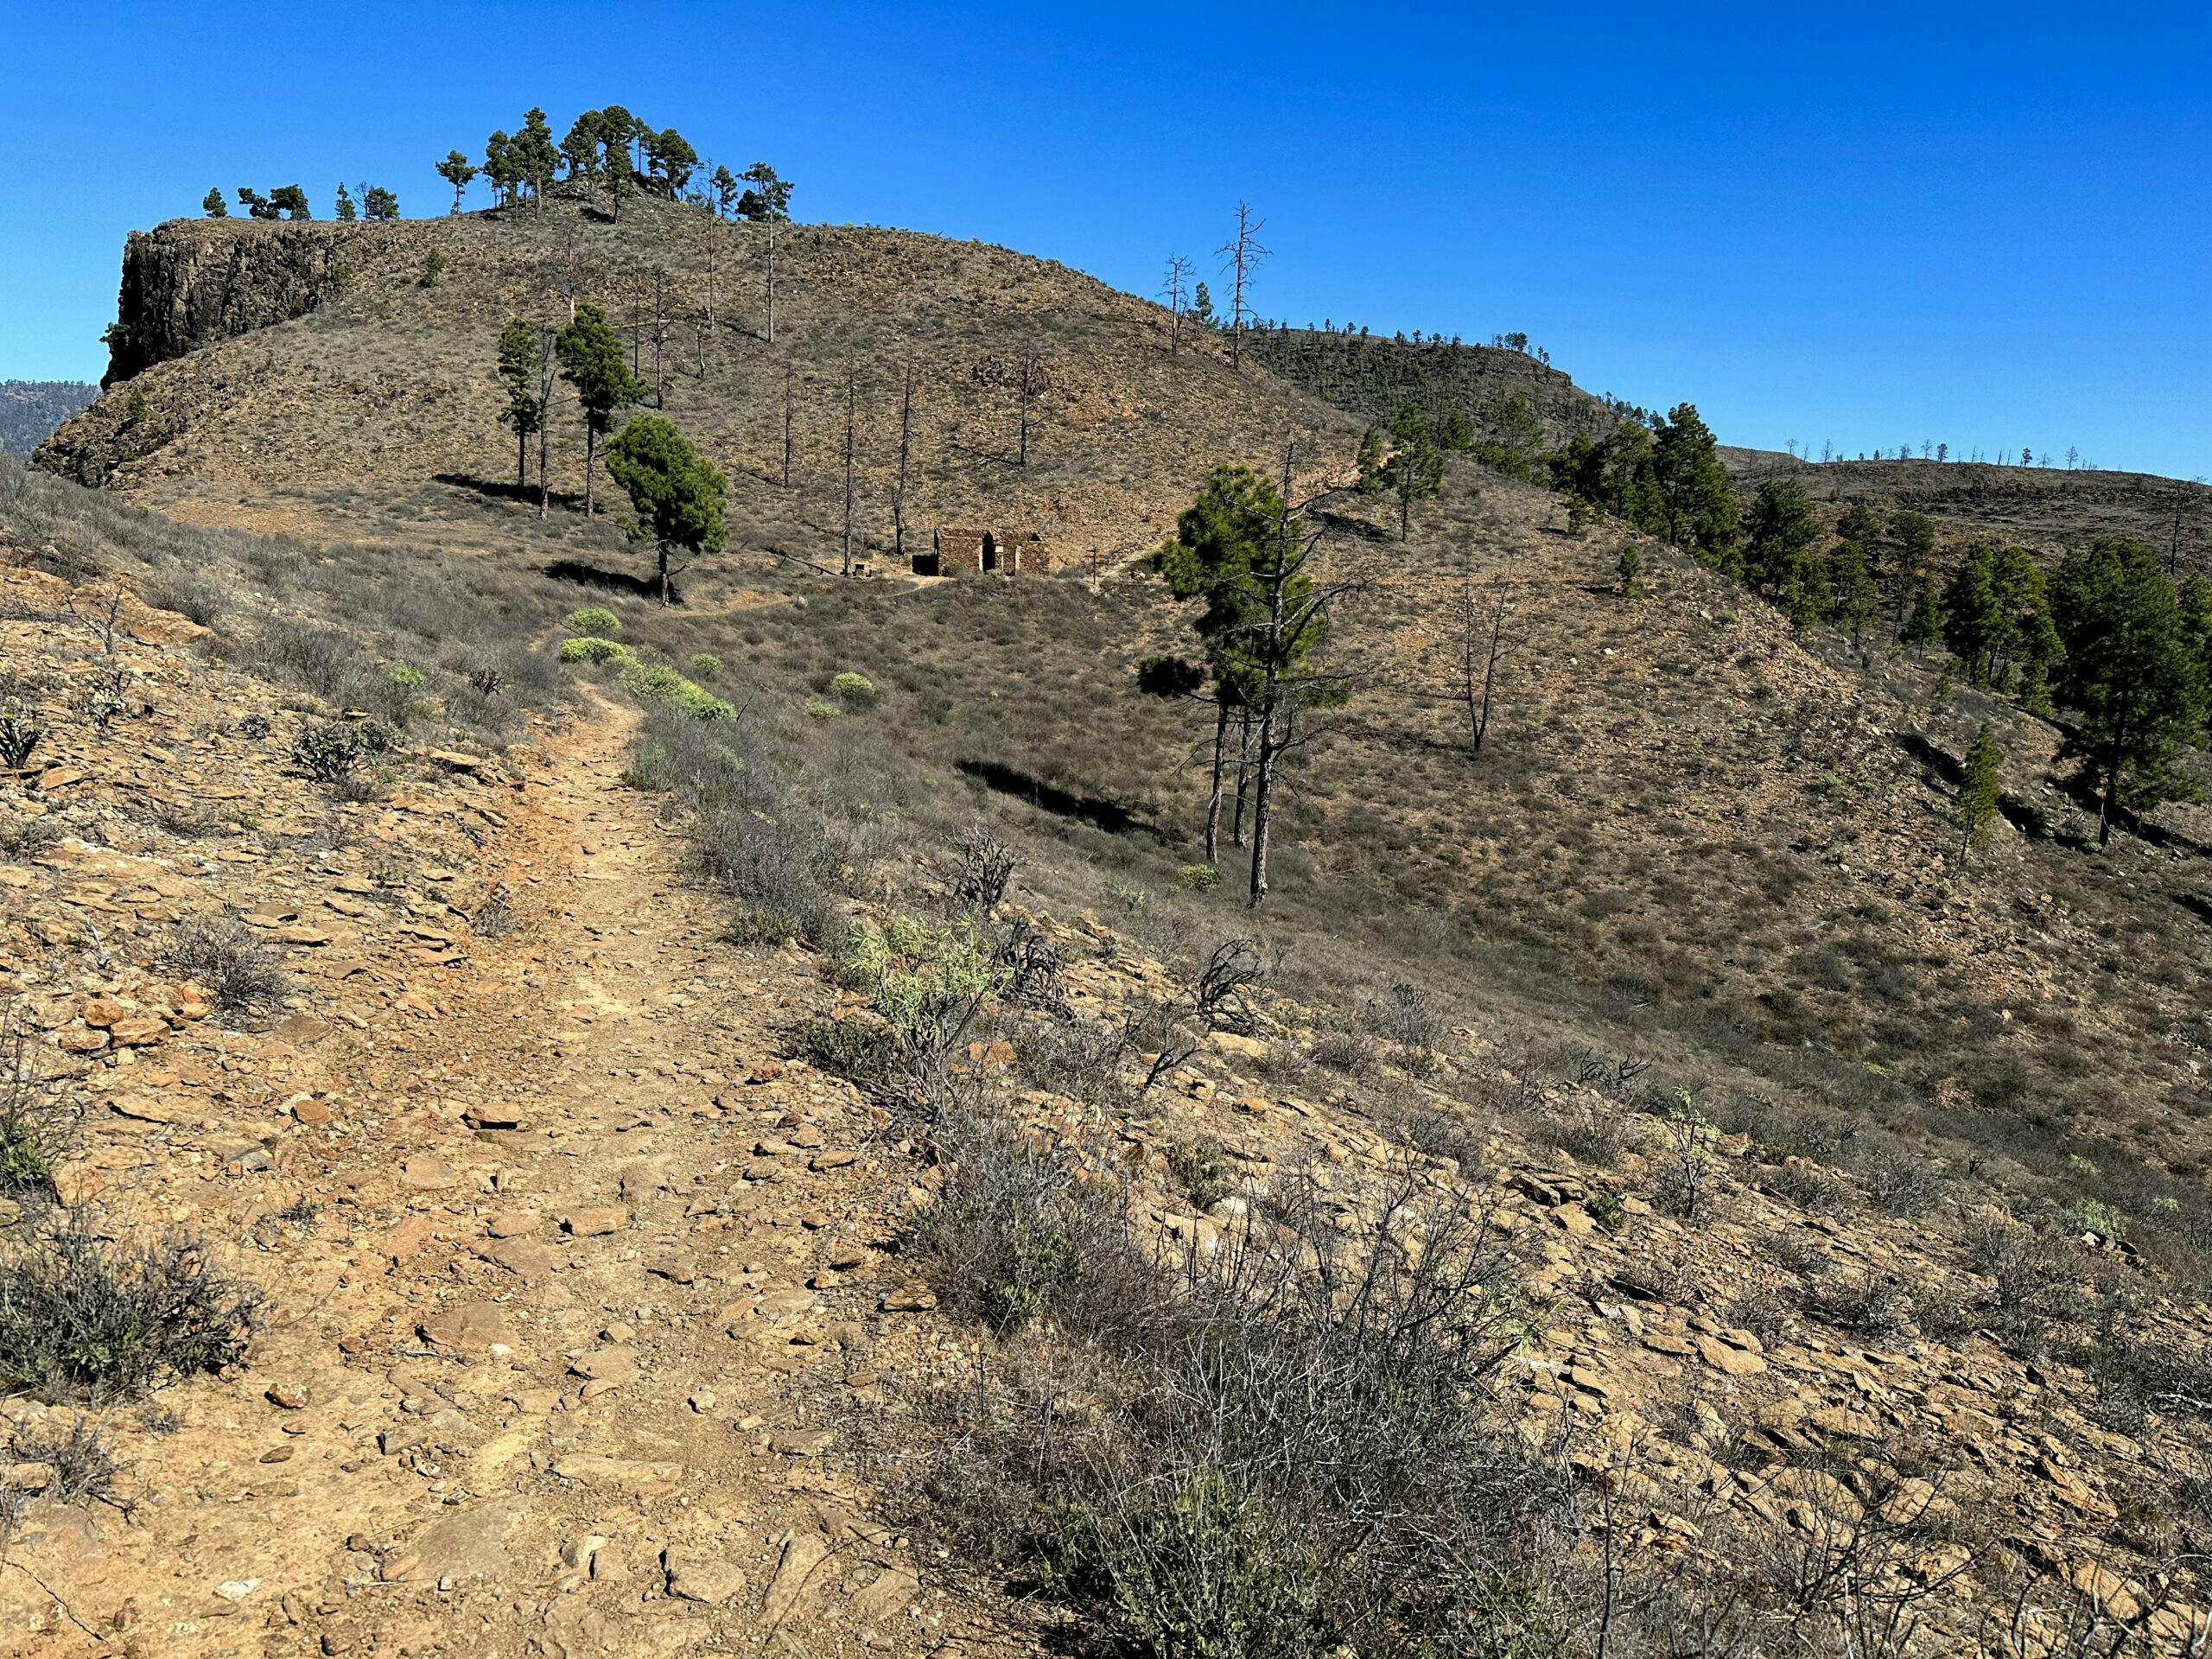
{"left": 916, "top": 1159, "right": 1573, "bottom": 1659}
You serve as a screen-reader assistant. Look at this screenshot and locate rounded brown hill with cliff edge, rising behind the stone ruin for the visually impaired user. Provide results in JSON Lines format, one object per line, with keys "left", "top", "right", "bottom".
{"left": 38, "top": 197, "right": 1358, "bottom": 562}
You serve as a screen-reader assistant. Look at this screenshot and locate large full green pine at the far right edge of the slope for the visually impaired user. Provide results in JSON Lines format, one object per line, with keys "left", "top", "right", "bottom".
{"left": 2050, "top": 537, "right": 2205, "bottom": 847}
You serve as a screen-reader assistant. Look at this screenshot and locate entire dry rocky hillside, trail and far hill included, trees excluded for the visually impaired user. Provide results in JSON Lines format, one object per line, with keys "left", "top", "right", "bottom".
{"left": 13, "top": 175, "right": 2212, "bottom": 1659}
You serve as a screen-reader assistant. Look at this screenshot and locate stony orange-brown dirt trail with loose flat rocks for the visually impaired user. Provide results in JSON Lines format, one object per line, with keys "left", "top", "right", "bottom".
{"left": 0, "top": 677, "right": 1013, "bottom": 1659}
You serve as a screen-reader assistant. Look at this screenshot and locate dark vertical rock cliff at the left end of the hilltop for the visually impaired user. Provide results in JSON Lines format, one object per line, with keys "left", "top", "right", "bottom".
{"left": 99, "top": 219, "right": 404, "bottom": 387}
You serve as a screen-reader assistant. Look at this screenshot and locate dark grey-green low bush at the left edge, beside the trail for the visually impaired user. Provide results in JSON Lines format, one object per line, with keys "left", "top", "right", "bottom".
{"left": 0, "top": 1210, "right": 261, "bottom": 1402}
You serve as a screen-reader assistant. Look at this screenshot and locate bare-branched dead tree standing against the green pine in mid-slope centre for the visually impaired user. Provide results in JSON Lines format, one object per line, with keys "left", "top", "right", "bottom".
{"left": 1243, "top": 445, "right": 1367, "bottom": 907}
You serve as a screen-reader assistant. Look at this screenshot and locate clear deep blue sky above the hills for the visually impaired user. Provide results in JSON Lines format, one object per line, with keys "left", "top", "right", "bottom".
{"left": 0, "top": 0, "right": 2212, "bottom": 475}
